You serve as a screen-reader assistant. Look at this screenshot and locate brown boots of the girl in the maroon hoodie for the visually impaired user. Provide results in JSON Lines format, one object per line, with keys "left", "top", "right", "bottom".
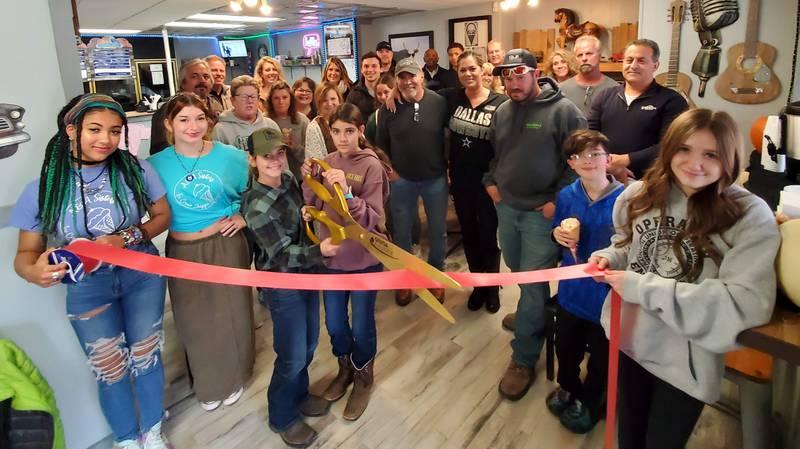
{"left": 322, "top": 355, "right": 375, "bottom": 421}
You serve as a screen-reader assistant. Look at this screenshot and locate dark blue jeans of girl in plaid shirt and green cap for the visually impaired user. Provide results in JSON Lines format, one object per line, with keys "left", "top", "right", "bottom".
{"left": 261, "top": 288, "right": 319, "bottom": 432}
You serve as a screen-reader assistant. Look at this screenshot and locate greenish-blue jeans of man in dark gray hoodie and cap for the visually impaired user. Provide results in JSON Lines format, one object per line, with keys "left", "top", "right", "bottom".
{"left": 496, "top": 203, "right": 558, "bottom": 368}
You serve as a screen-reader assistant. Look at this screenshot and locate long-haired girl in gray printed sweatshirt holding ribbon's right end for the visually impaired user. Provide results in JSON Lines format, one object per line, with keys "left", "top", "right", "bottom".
{"left": 590, "top": 109, "right": 780, "bottom": 449}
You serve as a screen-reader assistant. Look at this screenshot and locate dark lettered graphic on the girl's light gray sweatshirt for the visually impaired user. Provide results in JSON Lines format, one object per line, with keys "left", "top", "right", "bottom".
{"left": 631, "top": 216, "right": 698, "bottom": 282}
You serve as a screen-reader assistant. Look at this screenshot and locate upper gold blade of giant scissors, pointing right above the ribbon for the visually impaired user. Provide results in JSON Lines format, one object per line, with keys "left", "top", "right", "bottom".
{"left": 345, "top": 224, "right": 461, "bottom": 290}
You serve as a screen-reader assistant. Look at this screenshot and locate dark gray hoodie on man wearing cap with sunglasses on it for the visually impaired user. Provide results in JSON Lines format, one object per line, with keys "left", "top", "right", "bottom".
{"left": 483, "top": 78, "right": 588, "bottom": 210}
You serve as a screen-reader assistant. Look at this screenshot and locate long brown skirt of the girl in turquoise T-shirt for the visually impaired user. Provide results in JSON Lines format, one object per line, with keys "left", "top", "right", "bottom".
{"left": 166, "top": 232, "right": 255, "bottom": 402}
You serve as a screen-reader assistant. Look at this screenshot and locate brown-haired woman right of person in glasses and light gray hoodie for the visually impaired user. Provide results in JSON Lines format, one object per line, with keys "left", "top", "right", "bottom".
{"left": 267, "top": 81, "right": 308, "bottom": 180}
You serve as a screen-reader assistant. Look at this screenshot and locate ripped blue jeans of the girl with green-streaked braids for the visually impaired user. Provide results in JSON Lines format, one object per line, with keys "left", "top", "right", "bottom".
{"left": 67, "top": 242, "right": 167, "bottom": 441}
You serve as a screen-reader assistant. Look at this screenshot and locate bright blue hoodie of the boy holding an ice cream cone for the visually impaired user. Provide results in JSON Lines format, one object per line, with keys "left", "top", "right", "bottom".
{"left": 553, "top": 177, "right": 624, "bottom": 323}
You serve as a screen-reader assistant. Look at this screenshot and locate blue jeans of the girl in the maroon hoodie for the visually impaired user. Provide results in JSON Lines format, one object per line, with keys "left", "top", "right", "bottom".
{"left": 322, "top": 264, "right": 383, "bottom": 367}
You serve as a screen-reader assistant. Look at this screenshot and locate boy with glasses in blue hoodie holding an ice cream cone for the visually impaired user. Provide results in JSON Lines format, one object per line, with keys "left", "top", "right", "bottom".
{"left": 546, "top": 130, "right": 624, "bottom": 433}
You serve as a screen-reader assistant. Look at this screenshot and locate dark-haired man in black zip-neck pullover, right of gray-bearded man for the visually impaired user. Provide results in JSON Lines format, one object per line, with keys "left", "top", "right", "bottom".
{"left": 588, "top": 39, "right": 689, "bottom": 178}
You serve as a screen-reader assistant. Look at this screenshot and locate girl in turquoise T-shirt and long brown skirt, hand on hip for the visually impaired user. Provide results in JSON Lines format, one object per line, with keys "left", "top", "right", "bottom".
{"left": 149, "top": 93, "right": 254, "bottom": 411}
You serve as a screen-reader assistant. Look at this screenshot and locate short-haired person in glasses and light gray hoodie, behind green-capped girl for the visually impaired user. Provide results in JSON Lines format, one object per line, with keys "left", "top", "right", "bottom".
{"left": 211, "top": 75, "right": 281, "bottom": 150}
